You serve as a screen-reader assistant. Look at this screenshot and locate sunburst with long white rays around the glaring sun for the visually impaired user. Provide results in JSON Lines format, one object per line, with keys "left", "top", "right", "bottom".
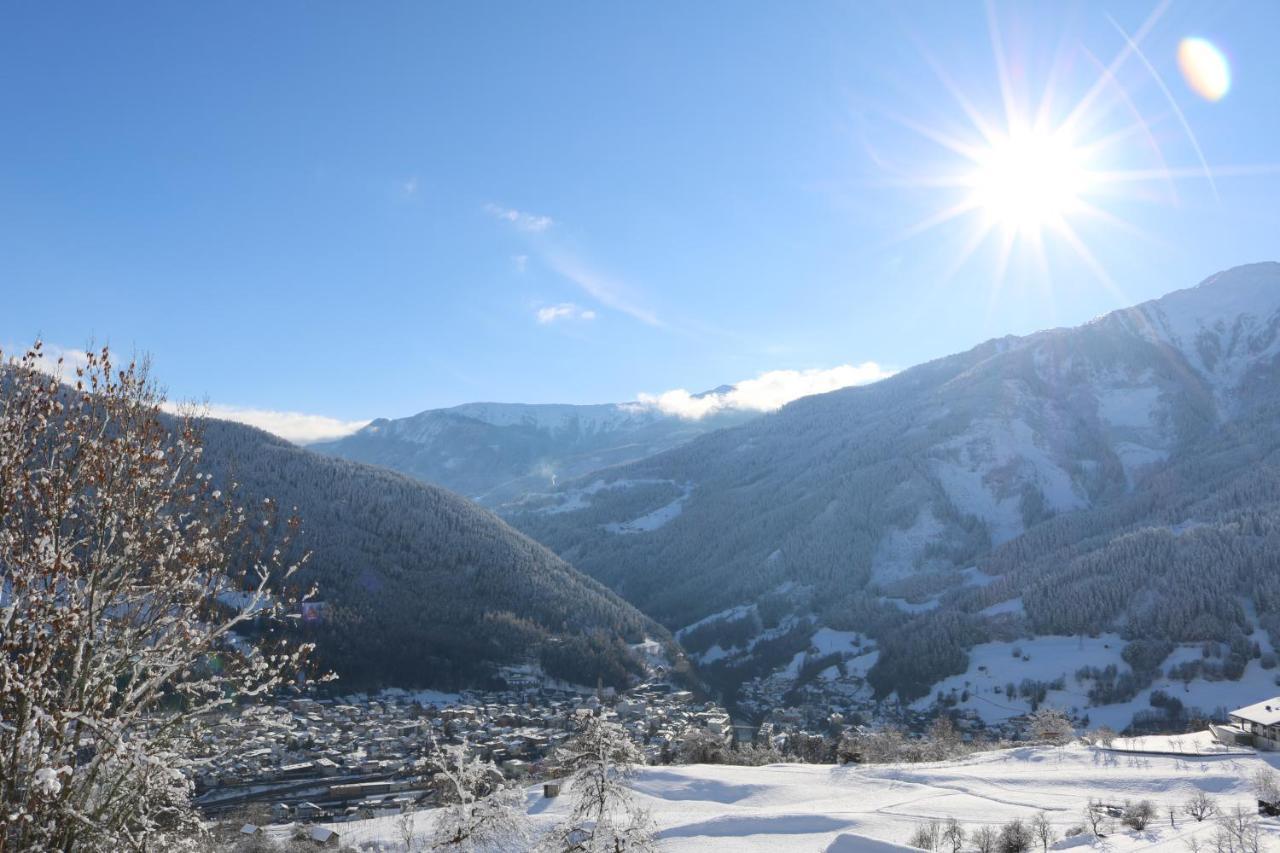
{"left": 880, "top": 0, "right": 1276, "bottom": 287}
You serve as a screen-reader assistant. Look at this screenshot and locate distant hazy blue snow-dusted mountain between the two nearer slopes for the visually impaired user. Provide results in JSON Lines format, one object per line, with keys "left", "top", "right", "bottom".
{"left": 311, "top": 388, "right": 754, "bottom": 506}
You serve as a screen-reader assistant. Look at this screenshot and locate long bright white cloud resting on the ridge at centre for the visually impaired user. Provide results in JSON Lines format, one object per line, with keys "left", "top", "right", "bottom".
{"left": 639, "top": 361, "right": 893, "bottom": 420}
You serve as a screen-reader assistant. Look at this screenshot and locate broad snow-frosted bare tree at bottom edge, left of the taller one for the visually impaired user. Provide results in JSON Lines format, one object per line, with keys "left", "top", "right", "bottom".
{"left": 430, "top": 742, "right": 530, "bottom": 853}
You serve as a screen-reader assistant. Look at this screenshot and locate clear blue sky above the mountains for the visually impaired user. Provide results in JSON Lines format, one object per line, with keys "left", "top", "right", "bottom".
{"left": 0, "top": 1, "right": 1280, "bottom": 440}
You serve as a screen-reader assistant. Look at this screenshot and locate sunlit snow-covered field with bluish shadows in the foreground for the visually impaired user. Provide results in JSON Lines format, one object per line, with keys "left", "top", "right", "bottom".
{"left": 293, "top": 736, "right": 1280, "bottom": 853}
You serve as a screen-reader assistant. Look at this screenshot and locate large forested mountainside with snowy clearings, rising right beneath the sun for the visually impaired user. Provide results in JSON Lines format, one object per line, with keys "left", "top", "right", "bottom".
{"left": 509, "top": 264, "right": 1280, "bottom": 713}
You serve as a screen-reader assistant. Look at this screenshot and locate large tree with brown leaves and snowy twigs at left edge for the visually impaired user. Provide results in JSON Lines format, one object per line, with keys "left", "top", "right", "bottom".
{"left": 0, "top": 343, "right": 320, "bottom": 850}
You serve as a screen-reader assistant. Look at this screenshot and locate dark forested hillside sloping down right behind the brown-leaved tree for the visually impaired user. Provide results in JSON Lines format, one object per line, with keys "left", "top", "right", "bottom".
{"left": 194, "top": 420, "right": 666, "bottom": 686}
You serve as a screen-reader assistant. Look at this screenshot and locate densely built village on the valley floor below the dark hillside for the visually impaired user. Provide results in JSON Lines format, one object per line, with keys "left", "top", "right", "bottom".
{"left": 193, "top": 681, "right": 732, "bottom": 822}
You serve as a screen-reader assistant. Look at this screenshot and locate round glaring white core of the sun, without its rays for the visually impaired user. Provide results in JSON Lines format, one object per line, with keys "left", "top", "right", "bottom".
{"left": 968, "top": 127, "right": 1091, "bottom": 238}
